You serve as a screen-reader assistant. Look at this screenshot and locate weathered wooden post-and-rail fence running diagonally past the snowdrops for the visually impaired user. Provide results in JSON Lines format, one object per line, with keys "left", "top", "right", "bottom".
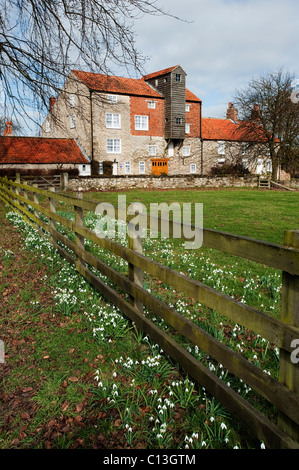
{"left": 0, "top": 175, "right": 299, "bottom": 449}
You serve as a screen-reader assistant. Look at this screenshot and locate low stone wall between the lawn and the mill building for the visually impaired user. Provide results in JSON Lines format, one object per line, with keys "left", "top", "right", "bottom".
{"left": 69, "top": 175, "right": 257, "bottom": 191}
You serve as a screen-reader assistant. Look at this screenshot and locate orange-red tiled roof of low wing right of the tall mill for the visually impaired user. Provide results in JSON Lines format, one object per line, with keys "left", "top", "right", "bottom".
{"left": 202, "top": 118, "right": 279, "bottom": 142}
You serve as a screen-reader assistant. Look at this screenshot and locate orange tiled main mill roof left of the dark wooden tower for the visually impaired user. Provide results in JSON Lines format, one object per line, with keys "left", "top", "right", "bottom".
{"left": 72, "top": 70, "right": 163, "bottom": 98}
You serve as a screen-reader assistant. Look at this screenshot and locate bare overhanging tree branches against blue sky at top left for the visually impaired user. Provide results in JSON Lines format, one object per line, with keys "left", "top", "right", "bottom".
{"left": 0, "top": 0, "right": 172, "bottom": 131}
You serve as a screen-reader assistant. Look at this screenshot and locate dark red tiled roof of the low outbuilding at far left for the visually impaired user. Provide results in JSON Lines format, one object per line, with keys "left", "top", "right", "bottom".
{"left": 0, "top": 136, "right": 89, "bottom": 164}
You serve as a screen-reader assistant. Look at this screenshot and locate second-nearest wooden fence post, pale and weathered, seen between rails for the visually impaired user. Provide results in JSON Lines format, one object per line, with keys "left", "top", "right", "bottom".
{"left": 127, "top": 205, "right": 143, "bottom": 313}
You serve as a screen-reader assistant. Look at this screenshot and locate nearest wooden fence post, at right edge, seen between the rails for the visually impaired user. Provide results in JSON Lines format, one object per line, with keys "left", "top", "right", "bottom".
{"left": 278, "top": 230, "right": 299, "bottom": 442}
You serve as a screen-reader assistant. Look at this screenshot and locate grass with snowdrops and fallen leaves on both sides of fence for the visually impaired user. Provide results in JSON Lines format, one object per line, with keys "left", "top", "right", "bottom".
{"left": 0, "top": 190, "right": 298, "bottom": 449}
